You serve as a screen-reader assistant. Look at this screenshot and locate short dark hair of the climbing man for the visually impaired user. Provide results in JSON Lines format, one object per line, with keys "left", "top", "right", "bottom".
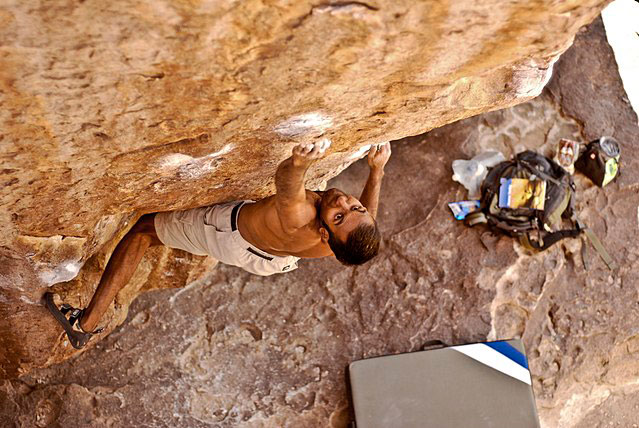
{"left": 325, "top": 220, "right": 382, "bottom": 266}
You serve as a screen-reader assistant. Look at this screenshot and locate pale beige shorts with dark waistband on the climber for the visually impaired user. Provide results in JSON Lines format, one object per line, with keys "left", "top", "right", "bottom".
{"left": 154, "top": 201, "right": 299, "bottom": 276}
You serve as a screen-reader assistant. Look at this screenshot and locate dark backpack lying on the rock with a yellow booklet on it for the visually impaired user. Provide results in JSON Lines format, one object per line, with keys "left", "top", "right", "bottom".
{"left": 465, "top": 150, "right": 616, "bottom": 269}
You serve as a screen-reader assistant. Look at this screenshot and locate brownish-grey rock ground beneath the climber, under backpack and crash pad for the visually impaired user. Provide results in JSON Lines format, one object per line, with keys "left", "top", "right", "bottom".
{"left": 0, "top": 16, "right": 639, "bottom": 428}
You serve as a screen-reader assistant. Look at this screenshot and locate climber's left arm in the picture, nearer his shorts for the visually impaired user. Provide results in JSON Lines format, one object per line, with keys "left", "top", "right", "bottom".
{"left": 275, "top": 140, "right": 331, "bottom": 232}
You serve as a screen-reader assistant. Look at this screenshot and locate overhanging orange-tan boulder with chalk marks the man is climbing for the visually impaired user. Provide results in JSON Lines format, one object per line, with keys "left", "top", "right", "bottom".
{"left": 0, "top": 0, "right": 607, "bottom": 378}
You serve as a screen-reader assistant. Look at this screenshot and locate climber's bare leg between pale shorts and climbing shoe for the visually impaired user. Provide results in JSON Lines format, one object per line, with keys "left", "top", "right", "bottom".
{"left": 80, "top": 214, "right": 162, "bottom": 332}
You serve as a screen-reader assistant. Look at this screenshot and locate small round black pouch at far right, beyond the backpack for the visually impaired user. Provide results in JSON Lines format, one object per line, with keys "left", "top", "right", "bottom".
{"left": 575, "top": 137, "right": 621, "bottom": 187}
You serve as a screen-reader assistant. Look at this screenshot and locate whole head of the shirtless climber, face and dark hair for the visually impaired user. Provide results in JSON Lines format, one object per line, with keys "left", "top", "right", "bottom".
{"left": 319, "top": 189, "right": 381, "bottom": 265}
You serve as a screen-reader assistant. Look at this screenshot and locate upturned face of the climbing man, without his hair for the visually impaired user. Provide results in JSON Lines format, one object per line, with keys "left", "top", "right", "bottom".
{"left": 320, "top": 189, "right": 374, "bottom": 242}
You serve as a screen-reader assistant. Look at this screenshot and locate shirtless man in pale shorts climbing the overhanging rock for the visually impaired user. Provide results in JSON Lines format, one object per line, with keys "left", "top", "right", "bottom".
{"left": 45, "top": 140, "right": 391, "bottom": 349}
